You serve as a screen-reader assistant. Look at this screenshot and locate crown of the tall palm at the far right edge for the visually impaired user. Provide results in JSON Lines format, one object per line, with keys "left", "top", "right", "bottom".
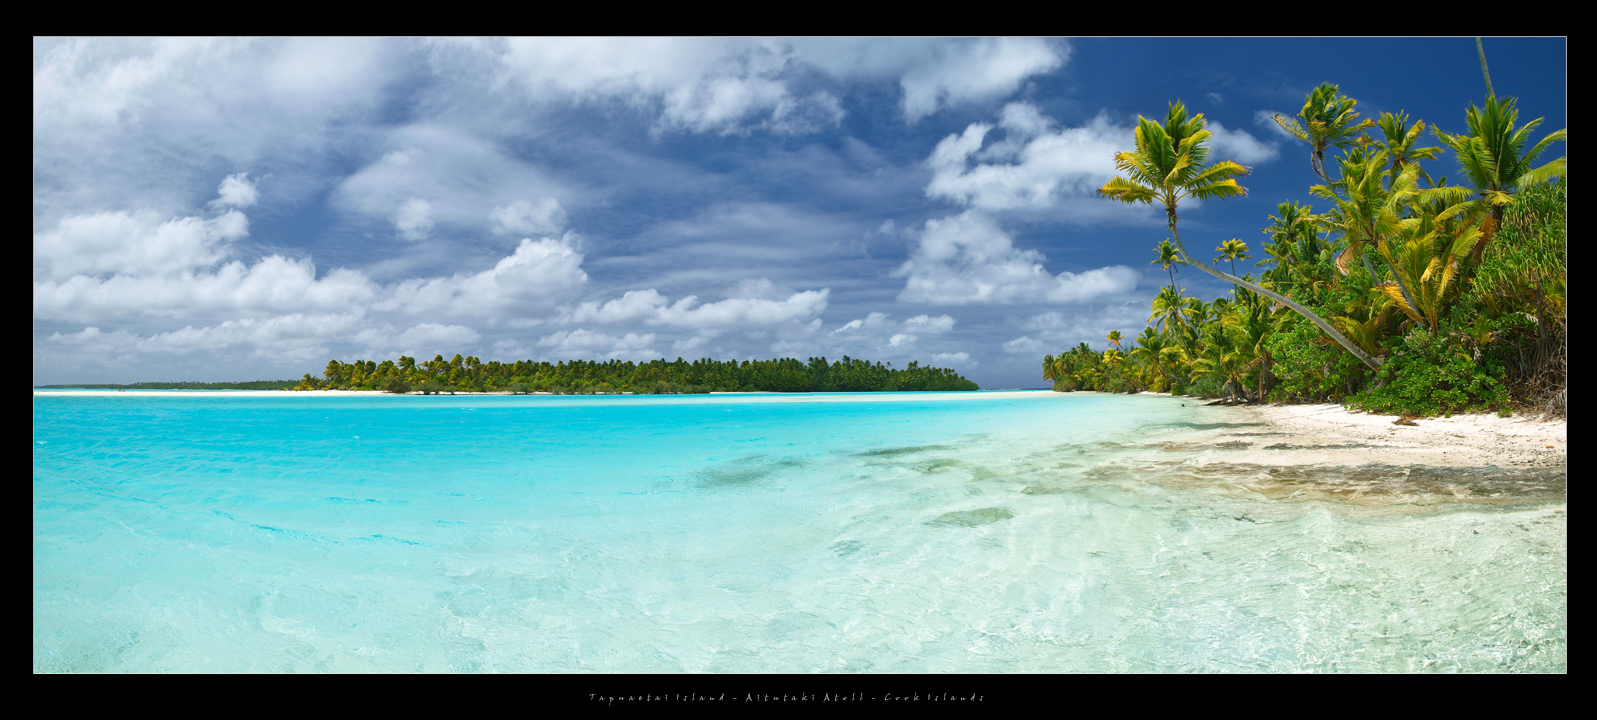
{"left": 1426, "top": 96, "right": 1568, "bottom": 263}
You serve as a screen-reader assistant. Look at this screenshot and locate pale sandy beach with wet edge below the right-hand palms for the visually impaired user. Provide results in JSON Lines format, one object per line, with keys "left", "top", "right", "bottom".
{"left": 1121, "top": 399, "right": 1568, "bottom": 512}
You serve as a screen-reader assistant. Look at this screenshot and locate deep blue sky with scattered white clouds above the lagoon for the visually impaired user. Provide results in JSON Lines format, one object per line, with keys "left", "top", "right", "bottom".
{"left": 34, "top": 38, "right": 1567, "bottom": 388}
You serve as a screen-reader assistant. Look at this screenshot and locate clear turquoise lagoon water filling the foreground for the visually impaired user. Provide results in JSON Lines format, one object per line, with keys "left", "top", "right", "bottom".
{"left": 34, "top": 393, "right": 1567, "bottom": 672}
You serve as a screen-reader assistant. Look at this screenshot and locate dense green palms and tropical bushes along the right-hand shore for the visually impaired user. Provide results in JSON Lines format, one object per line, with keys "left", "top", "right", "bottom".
{"left": 1043, "top": 57, "right": 1568, "bottom": 415}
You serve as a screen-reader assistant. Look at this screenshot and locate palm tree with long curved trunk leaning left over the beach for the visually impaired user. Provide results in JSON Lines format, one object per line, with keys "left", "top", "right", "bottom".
{"left": 1099, "top": 102, "right": 1380, "bottom": 369}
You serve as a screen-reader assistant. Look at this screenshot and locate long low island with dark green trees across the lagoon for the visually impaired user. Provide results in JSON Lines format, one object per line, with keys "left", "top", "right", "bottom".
{"left": 293, "top": 354, "right": 981, "bottom": 394}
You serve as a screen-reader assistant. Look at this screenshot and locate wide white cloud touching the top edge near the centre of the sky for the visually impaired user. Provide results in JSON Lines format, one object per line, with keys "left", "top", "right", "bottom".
{"left": 485, "top": 38, "right": 1070, "bottom": 134}
